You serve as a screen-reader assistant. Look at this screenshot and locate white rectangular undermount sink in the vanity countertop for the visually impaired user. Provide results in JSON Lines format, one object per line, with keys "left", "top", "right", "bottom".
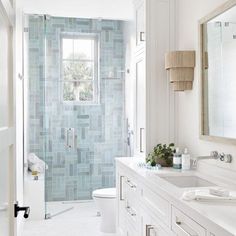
{"left": 159, "top": 176, "right": 215, "bottom": 188}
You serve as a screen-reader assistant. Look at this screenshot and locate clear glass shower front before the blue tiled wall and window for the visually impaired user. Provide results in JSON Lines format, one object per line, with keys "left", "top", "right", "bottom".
{"left": 42, "top": 16, "right": 125, "bottom": 218}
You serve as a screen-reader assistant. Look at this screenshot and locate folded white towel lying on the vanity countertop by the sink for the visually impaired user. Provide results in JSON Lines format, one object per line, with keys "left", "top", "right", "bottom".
{"left": 182, "top": 189, "right": 236, "bottom": 203}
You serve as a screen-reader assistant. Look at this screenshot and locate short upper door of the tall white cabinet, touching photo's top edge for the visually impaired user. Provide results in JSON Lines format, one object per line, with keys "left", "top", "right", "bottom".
{"left": 135, "top": 0, "right": 145, "bottom": 48}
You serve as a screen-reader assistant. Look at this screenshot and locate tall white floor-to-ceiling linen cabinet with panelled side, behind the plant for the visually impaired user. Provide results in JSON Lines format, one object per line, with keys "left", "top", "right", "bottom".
{"left": 132, "top": 0, "right": 176, "bottom": 157}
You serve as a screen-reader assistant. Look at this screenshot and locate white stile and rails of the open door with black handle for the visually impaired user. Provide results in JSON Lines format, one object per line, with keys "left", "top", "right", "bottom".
{"left": 0, "top": 0, "right": 17, "bottom": 236}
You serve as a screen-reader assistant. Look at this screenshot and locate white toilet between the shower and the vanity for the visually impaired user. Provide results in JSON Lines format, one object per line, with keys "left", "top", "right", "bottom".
{"left": 93, "top": 188, "right": 116, "bottom": 233}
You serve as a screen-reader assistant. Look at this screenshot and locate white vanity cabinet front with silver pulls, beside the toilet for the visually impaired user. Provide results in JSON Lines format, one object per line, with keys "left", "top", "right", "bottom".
{"left": 116, "top": 158, "right": 235, "bottom": 236}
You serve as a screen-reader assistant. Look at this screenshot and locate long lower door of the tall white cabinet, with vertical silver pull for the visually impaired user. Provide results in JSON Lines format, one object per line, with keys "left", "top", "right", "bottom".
{"left": 135, "top": 53, "right": 146, "bottom": 156}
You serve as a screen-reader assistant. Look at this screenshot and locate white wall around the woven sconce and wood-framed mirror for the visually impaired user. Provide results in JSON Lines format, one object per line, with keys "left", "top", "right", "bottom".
{"left": 176, "top": 0, "right": 236, "bottom": 171}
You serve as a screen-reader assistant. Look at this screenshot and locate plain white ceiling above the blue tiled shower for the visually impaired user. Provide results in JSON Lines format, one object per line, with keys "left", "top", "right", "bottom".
{"left": 23, "top": 0, "right": 133, "bottom": 20}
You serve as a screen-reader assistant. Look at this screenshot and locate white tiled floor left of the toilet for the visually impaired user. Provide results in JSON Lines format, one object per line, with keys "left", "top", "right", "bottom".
{"left": 23, "top": 201, "right": 115, "bottom": 236}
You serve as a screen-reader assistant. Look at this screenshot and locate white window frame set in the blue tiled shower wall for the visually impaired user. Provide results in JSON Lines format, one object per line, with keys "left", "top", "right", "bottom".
{"left": 60, "top": 32, "right": 100, "bottom": 105}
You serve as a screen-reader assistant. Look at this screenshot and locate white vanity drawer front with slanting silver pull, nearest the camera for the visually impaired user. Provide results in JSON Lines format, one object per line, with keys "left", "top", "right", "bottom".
{"left": 171, "top": 206, "right": 206, "bottom": 236}
